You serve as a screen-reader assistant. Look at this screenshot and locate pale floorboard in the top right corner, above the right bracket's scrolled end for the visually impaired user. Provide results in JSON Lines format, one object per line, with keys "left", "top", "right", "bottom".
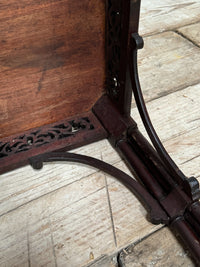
{"left": 140, "top": 0, "right": 200, "bottom": 35}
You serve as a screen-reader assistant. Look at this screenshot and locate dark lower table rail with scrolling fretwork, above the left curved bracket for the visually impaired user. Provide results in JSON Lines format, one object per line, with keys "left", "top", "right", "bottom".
{"left": 0, "top": 111, "right": 107, "bottom": 174}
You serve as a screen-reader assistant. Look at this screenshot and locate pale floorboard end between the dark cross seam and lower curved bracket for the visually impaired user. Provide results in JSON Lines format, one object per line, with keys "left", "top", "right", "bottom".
{"left": 105, "top": 178, "right": 160, "bottom": 249}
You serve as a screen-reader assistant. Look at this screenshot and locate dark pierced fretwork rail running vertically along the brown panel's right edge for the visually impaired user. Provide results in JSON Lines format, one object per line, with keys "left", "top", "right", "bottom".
{"left": 106, "top": 0, "right": 132, "bottom": 115}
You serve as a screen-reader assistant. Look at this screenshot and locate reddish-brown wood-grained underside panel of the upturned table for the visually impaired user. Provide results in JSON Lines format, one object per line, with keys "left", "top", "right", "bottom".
{"left": 0, "top": 0, "right": 105, "bottom": 137}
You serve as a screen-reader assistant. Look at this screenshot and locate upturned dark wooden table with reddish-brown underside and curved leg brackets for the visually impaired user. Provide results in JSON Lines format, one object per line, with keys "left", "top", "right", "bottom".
{"left": 0, "top": 0, "right": 200, "bottom": 264}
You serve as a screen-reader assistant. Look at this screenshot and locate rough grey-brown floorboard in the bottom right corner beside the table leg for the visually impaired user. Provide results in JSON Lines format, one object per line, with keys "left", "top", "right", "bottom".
{"left": 120, "top": 228, "right": 195, "bottom": 267}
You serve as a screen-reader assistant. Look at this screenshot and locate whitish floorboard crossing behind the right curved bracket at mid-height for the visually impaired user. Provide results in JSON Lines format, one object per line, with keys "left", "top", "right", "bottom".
{"left": 131, "top": 84, "right": 200, "bottom": 142}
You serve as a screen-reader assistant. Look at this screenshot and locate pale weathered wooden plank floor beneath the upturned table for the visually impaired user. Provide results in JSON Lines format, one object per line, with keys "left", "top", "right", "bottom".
{"left": 0, "top": 0, "right": 200, "bottom": 267}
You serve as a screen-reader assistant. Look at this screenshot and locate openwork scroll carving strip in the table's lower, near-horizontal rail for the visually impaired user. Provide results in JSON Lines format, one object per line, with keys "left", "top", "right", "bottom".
{"left": 0, "top": 117, "right": 94, "bottom": 158}
